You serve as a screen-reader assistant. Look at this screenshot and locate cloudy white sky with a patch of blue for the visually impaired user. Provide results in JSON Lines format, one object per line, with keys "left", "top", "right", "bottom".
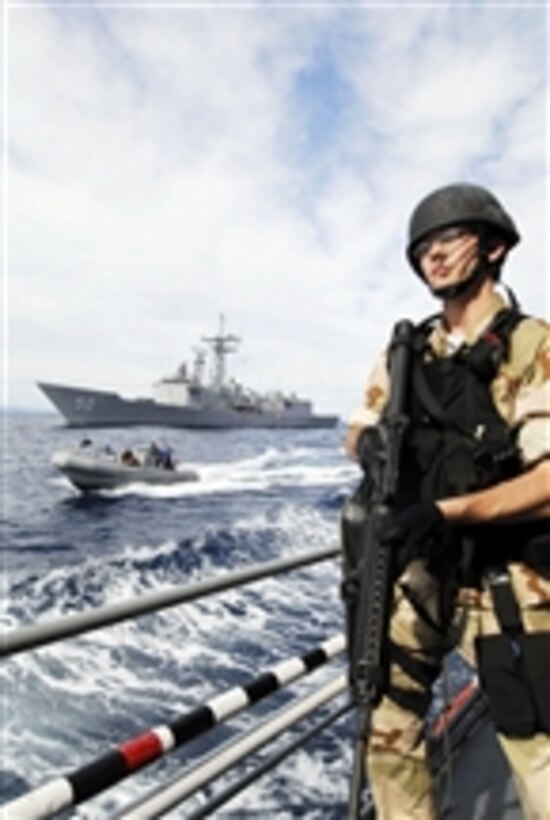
{"left": 2, "top": 0, "right": 549, "bottom": 418}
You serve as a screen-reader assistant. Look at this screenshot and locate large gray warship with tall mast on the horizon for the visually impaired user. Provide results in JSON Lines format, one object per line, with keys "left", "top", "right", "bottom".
{"left": 38, "top": 316, "right": 338, "bottom": 429}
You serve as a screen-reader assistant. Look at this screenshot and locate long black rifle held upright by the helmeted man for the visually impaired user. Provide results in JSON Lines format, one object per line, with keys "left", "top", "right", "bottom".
{"left": 348, "top": 319, "right": 414, "bottom": 820}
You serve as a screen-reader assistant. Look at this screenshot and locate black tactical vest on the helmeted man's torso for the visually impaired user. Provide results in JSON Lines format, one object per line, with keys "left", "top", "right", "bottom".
{"left": 399, "top": 308, "right": 548, "bottom": 582}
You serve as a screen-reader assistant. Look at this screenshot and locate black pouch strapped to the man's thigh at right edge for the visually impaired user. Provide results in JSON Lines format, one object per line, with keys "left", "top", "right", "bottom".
{"left": 475, "top": 632, "right": 550, "bottom": 737}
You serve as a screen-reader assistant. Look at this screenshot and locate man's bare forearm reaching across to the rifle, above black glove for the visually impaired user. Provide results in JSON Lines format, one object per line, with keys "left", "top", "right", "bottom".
{"left": 437, "top": 458, "right": 550, "bottom": 524}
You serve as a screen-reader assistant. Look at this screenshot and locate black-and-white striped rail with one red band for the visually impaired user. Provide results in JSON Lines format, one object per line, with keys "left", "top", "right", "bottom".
{"left": 0, "top": 635, "right": 345, "bottom": 820}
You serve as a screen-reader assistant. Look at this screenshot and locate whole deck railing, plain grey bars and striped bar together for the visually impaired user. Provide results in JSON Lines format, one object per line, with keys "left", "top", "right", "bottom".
{"left": 0, "top": 546, "right": 351, "bottom": 820}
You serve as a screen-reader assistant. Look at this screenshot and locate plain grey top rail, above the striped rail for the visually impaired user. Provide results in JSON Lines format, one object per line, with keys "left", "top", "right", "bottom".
{"left": 0, "top": 546, "right": 340, "bottom": 657}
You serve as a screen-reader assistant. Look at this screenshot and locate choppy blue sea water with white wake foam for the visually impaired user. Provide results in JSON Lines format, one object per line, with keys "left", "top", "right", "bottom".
{"left": 0, "top": 414, "right": 358, "bottom": 820}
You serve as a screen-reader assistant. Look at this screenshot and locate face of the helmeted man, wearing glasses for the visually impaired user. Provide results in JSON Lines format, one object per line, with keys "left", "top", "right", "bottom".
{"left": 414, "top": 226, "right": 479, "bottom": 291}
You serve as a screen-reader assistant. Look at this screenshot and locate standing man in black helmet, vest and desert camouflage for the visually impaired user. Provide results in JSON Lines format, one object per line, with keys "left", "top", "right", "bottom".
{"left": 346, "top": 184, "right": 550, "bottom": 820}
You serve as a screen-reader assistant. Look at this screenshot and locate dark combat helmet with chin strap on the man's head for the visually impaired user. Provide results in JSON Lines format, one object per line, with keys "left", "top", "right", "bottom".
{"left": 407, "top": 182, "right": 520, "bottom": 295}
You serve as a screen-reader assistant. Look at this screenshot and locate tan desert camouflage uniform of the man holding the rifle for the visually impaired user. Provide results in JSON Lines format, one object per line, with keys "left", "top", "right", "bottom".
{"left": 350, "top": 294, "right": 550, "bottom": 820}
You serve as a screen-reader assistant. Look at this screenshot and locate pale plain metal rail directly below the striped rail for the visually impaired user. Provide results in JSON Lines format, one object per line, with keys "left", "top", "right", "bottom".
{"left": 117, "top": 673, "right": 348, "bottom": 820}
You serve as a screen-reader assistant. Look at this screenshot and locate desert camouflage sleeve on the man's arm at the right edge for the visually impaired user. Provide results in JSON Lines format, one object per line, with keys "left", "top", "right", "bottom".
{"left": 512, "top": 320, "right": 550, "bottom": 466}
